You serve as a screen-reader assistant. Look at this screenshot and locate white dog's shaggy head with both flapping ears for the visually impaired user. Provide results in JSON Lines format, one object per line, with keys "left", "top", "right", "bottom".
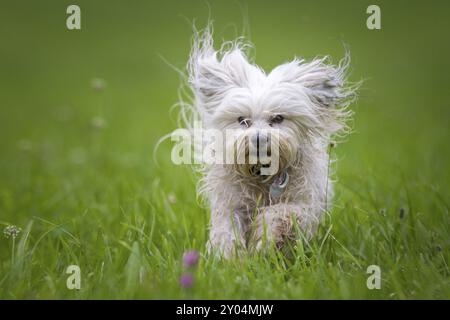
{"left": 190, "top": 40, "right": 351, "bottom": 177}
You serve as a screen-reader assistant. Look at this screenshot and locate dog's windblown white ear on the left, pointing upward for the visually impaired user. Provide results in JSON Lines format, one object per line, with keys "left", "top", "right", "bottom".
{"left": 188, "top": 33, "right": 255, "bottom": 114}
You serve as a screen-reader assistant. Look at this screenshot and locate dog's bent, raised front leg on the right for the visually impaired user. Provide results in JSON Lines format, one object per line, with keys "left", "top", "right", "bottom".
{"left": 249, "top": 203, "right": 319, "bottom": 252}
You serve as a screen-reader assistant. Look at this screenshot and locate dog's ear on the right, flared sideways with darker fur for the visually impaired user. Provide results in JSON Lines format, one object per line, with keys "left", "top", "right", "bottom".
{"left": 271, "top": 55, "right": 357, "bottom": 133}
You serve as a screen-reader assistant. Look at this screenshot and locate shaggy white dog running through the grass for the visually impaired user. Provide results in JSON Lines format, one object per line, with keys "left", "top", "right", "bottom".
{"left": 178, "top": 28, "right": 355, "bottom": 258}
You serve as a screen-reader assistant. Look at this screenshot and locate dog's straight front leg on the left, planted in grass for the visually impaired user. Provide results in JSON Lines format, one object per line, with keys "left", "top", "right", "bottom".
{"left": 207, "top": 210, "right": 248, "bottom": 259}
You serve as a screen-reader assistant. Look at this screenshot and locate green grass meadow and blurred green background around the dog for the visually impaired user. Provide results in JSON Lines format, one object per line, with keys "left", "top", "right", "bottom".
{"left": 0, "top": 1, "right": 450, "bottom": 299}
